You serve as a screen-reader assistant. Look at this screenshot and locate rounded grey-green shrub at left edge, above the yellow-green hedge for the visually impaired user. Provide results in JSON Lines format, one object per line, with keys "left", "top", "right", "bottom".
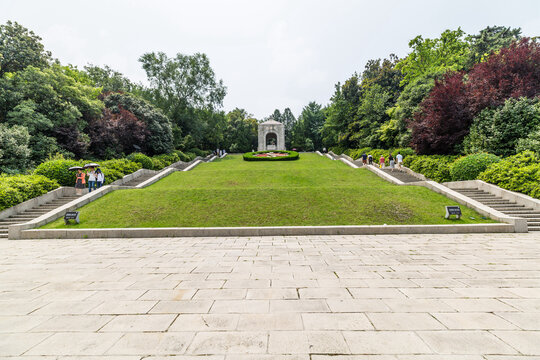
{"left": 0, "top": 123, "right": 30, "bottom": 173}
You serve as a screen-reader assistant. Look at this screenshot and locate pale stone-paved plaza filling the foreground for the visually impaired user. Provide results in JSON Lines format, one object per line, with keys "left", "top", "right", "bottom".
{"left": 0, "top": 234, "right": 540, "bottom": 360}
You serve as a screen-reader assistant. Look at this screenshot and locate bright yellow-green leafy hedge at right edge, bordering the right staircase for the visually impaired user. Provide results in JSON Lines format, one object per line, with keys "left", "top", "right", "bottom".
{"left": 478, "top": 151, "right": 540, "bottom": 199}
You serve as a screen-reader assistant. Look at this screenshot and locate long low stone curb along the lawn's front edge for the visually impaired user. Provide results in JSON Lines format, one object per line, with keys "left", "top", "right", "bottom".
{"left": 15, "top": 224, "right": 514, "bottom": 239}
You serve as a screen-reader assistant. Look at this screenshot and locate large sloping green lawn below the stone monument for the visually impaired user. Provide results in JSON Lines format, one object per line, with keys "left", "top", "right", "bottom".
{"left": 44, "top": 154, "right": 493, "bottom": 228}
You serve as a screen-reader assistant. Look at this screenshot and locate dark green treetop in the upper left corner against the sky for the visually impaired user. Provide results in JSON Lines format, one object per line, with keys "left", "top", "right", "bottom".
{"left": 0, "top": 21, "right": 51, "bottom": 76}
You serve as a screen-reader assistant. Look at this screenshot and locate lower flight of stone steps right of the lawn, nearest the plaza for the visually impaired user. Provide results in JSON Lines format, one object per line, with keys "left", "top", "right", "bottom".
{"left": 453, "top": 188, "right": 540, "bottom": 231}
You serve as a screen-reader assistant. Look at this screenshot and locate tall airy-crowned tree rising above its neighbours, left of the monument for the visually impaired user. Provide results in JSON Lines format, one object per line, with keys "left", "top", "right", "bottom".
{"left": 139, "top": 52, "right": 227, "bottom": 142}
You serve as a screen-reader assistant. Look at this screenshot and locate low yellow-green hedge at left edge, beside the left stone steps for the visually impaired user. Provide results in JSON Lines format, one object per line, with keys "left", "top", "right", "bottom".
{"left": 0, "top": 175, "right": 60, "bottom": 210}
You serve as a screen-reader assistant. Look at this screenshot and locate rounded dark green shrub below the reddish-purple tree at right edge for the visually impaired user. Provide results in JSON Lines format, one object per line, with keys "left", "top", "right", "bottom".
{"left": 463, "top": 98, "right": 540, "bottom": 156}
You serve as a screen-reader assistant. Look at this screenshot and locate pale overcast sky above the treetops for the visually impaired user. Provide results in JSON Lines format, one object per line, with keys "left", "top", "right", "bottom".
{"left": 0, "top": 0, "right": 540, "bottom": 119}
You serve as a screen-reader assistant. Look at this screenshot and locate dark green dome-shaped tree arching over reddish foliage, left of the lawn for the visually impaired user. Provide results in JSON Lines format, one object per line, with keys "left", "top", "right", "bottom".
{"left": 103, "top": 93, "right": 173, "bottom": 155}
